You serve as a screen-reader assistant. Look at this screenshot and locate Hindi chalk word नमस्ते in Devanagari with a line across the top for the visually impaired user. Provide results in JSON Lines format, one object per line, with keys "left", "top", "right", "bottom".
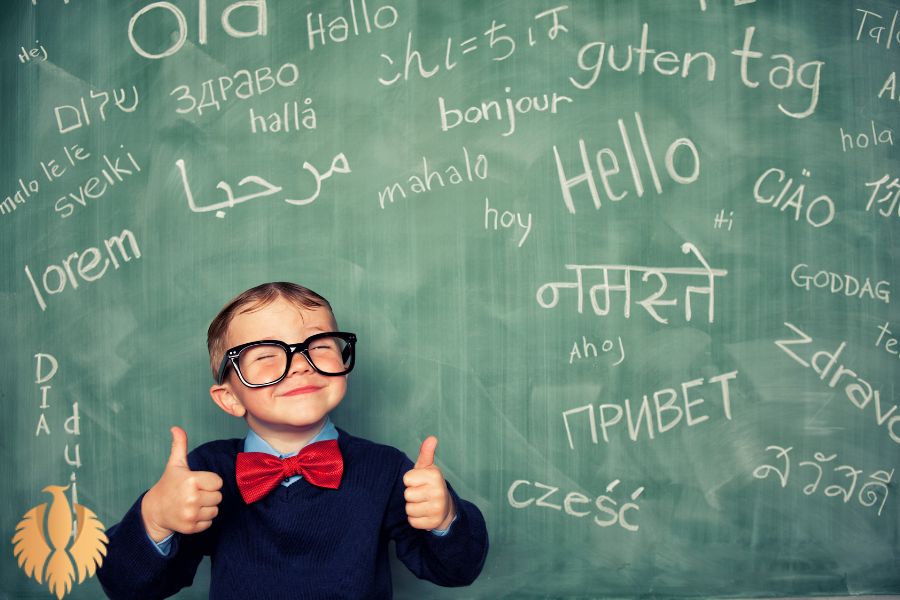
{"left": 537, "top": 242, "right": 728, "bottom": 324}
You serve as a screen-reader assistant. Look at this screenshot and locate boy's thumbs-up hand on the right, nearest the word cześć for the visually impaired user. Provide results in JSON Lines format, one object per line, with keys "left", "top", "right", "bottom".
{"left": 403, "top": 435, "right": 456, "bottom": 529}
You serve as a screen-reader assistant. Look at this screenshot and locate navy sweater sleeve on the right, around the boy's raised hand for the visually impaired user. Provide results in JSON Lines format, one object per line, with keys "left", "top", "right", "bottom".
{"left": 387, "top": 456, "right": 488, "bottom": 587}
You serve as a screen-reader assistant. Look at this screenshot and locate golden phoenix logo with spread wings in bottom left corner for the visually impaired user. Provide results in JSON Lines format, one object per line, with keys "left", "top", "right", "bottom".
{"left": 12, "top": 485, "right": 109, "bottom": 600}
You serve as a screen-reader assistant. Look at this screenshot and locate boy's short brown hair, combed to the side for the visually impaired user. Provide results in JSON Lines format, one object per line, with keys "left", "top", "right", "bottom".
{"left": 206, "top": 281, "right": 334, "bottom": 377}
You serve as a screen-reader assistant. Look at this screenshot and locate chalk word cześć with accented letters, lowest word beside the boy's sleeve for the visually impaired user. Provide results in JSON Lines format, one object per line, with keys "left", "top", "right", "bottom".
{"left": 506, "top": 479, "right": 644, "bottom": 531}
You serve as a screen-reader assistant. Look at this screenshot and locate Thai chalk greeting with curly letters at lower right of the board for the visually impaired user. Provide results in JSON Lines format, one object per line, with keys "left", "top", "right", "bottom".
{"left": 753, "top": 445, "right": 894, "bottom": 516}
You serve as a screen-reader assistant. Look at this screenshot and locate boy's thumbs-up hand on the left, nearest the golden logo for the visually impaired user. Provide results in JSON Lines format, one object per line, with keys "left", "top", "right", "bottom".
{"left": 141, "top": 427, "right": 222, "bottom": 542}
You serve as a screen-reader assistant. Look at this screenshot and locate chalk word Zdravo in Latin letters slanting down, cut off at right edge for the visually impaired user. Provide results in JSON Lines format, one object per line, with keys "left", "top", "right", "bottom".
{"left": 775, "top": 322, "right": 900, "bottom": 444}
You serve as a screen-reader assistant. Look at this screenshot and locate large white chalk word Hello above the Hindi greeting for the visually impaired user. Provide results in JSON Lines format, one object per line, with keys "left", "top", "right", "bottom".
{"left": 553, "top": 113, "right": 700, "bottom": 214}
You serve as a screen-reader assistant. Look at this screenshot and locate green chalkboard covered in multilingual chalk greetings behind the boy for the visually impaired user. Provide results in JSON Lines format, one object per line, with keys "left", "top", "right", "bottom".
{"left": 0, "top": 0, "right": 900, "bottom": 598}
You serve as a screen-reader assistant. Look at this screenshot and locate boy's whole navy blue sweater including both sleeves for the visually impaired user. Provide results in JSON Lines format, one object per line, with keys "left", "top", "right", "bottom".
{"left": 97, "top": 430, "right": 488, "bottom": 600}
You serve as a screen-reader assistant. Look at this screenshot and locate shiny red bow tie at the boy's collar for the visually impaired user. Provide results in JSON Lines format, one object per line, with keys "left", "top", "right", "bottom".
{"left": 236, "top": 440, "right": 344, "bottom": 504}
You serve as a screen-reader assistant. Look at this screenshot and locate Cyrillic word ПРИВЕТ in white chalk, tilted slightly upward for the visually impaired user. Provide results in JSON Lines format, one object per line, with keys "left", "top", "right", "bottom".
{"left": 562, "top": 371, "right": 738, "bottom": 450}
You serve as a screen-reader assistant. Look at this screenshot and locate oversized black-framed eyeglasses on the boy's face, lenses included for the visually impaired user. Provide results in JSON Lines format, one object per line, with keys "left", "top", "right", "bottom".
{"left": 216, "top": 331, "right": 356, "bottom": 388}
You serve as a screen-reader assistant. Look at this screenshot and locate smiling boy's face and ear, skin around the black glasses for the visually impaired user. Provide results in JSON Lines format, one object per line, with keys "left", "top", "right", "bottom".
{"left": 210, "top": 298, "right": 347, "bottom": 445}
